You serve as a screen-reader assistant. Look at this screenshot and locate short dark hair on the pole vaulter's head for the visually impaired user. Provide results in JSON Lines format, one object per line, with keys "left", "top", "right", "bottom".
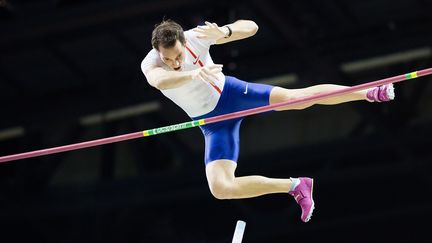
{"left": 152, "top": 19, "right": 186, "bottom": 51}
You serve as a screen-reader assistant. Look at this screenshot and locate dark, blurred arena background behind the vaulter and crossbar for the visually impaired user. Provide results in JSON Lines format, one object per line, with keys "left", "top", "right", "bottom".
{"left": 0, "top": 0, "right": 432, "bottom": 243}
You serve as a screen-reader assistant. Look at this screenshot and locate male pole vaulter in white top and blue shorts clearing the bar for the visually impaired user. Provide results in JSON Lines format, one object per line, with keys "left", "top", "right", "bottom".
{"left": 141, "top": 20, "right": 394, "bottom": 222}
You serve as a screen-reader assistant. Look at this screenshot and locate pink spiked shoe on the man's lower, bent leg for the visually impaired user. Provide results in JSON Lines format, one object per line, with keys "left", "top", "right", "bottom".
{"left": 289, "top": 177, "right": 315, "bottom": 222}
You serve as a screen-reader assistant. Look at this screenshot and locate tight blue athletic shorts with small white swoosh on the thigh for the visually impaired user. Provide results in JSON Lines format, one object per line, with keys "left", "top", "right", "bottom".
{"left": 192, "top": 76, "right": 273, "bottom": 165}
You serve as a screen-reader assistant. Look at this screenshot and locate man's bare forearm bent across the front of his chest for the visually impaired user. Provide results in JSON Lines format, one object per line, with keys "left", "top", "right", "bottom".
{"left": 143, "top": 64, "right": 222, "bottom": 90}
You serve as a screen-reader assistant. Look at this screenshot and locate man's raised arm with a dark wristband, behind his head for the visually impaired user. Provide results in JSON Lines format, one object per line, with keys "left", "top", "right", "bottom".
{"left": 194, "top": 20, "right": 258, "bottom": 44}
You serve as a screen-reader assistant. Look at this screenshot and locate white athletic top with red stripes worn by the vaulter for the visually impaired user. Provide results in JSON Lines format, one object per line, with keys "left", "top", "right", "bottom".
{"left": 141, "top": 30, "right": 225, "bottom": 117}
